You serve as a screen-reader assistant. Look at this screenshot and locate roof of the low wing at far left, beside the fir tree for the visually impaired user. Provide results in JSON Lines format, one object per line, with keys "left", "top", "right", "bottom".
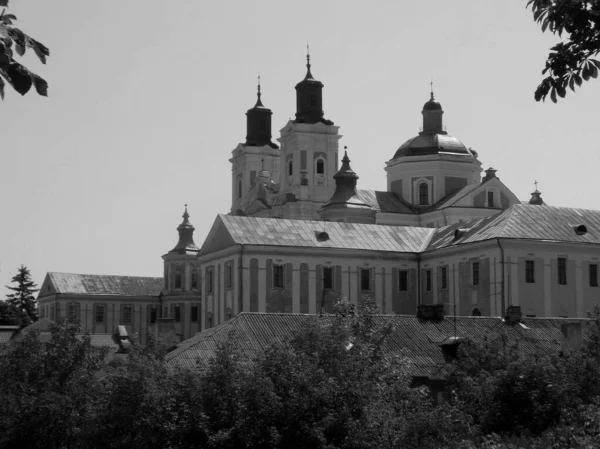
{"left": 48, "top": 273, "right": 164, "bottom": 296}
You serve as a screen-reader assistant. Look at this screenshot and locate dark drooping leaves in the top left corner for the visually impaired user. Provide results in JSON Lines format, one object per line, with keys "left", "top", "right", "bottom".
{"left": 0, "top": 0, "right": 50, "bottom": 100}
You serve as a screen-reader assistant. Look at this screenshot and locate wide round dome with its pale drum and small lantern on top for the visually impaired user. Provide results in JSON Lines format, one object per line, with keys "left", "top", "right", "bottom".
{"left": 385, "top": 90, "right": 481, "bottom": 207}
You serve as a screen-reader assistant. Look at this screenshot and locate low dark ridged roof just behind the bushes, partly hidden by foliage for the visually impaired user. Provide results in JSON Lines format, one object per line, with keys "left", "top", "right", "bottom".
{"left": 166, "top": 312, "right": 590, "bottom": 379}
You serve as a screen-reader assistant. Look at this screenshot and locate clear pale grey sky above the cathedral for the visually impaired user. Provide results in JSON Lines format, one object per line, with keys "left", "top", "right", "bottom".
{"left": 0, "top": 0, "right": 600, "bottom": 292}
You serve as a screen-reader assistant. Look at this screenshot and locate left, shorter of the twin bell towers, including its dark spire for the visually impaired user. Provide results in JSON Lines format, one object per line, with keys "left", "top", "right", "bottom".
{"left": 229, "top": 76, "right": 280, "bottom": 215}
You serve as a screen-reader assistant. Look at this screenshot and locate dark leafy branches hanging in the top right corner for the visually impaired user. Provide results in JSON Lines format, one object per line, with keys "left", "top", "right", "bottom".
{"left": 527, "top": 0, "right": 600, "bottom": 103}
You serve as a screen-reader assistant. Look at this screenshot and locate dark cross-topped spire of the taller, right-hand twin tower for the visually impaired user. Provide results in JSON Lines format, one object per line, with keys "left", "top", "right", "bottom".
{"left": 294, "top": 45, "right": 333, "bottom": 125}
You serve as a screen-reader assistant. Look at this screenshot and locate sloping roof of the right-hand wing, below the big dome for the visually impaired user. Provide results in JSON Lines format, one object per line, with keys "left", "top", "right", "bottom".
{"left": 427, "top": 204, "right": 600, "bottom": 250}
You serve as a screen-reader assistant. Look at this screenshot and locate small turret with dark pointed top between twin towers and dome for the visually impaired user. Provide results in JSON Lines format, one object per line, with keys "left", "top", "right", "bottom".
{"left": 319, "top": 147, "right": 376, "bottom": 223}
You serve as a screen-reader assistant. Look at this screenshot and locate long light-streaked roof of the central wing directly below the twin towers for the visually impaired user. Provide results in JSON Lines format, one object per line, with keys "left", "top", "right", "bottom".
{"left": 218, "top": 215, "right": 434, "bottom": 253}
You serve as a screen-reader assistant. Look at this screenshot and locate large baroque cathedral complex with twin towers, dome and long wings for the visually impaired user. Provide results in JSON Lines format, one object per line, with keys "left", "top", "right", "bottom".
{"left": 38, "top": 56, "right": 600, "bottom": 342}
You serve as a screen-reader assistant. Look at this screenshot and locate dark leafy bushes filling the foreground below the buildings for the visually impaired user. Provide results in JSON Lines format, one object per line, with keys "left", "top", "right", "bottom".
{"left": 0, "top": 303, "right": 600, "bottom": 449}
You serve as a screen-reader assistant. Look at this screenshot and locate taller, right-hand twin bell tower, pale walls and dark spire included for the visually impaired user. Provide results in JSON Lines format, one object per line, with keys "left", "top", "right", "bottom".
{"left": 277, "top": 49, "right": 342, "bottom": 220}
